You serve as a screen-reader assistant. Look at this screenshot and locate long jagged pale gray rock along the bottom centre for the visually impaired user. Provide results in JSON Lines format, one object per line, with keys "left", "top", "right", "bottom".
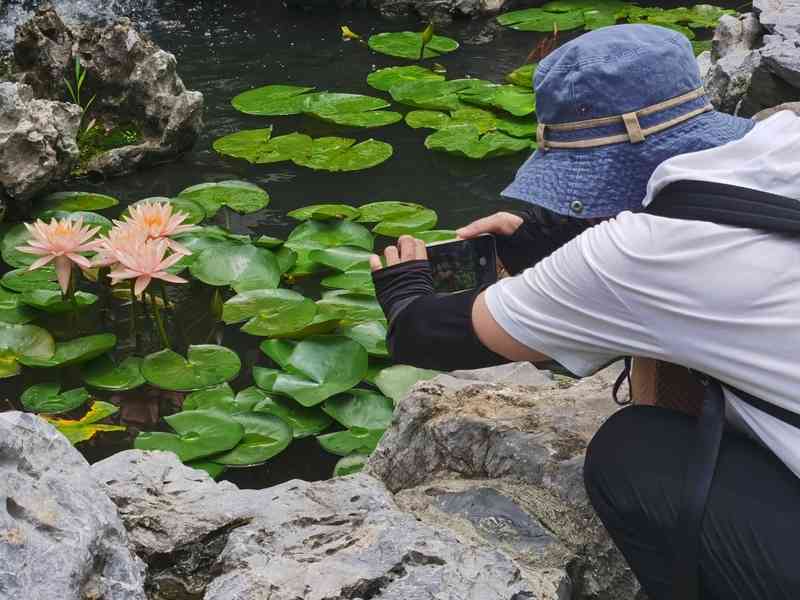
{"left": 93, "top": 450, "right": 539, "bottom": 600}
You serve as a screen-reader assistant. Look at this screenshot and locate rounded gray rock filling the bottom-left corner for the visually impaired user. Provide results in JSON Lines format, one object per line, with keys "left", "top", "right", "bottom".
{"left": 0, "top": 412, "right": 145, "bottom": 600}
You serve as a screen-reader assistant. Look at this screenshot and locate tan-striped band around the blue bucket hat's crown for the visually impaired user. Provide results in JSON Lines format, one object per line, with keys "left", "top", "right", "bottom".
{"left": 536, "top": 86, "right": 714, "bottom": 151}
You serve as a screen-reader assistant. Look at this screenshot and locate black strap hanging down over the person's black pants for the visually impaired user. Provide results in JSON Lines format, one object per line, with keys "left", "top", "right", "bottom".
{"left": 672, "top": 376, "right": 725, "bottom": 600}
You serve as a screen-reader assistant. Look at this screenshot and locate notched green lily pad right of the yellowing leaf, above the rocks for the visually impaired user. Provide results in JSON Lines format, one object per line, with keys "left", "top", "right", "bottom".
{"left": 133, "top": 410, "right": 244, "bottom": 462}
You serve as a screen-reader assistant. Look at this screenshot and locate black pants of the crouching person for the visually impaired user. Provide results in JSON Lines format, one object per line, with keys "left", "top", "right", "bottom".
{"left": 584, "top": 406, "right": 800, "bottom": 600}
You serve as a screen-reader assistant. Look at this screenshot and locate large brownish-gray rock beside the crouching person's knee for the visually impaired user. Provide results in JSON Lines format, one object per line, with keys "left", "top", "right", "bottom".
{"left": 366, "top": 367, "right": 639, "bottom": 600}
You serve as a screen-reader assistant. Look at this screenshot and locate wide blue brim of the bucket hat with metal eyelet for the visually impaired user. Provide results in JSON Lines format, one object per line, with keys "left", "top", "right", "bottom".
{"left": 502, "top": 111, "right": 754, "bottom": 219}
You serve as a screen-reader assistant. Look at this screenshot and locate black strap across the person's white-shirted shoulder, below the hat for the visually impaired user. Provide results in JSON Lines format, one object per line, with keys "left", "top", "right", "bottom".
{"left": 645, "top": 181, "right": 800, "bottom": 235}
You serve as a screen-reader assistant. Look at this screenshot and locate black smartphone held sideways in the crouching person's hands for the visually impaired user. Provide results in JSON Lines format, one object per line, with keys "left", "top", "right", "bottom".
{"left": 427, "top": 234, "right": 497, "bottom": 293}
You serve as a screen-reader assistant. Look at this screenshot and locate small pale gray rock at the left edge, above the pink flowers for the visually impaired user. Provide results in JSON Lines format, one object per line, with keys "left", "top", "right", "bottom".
{"left": 0, "top": 82, "right": 81, "bottom": 205}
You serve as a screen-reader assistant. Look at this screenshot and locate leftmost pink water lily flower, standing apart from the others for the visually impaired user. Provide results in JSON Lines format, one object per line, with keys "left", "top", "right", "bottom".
{"left": 17, "top": 218, "right": 100, "bottom": 294}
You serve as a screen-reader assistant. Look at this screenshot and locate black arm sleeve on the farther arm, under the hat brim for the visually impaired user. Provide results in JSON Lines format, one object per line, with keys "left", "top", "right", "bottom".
{"left": 495, "top": 207, "right": 592, "bottom": 275}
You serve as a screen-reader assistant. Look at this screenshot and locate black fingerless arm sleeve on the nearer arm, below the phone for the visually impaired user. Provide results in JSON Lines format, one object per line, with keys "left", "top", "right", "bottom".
{"left": 373, "top": 260, "right": 511, "bottom": 371}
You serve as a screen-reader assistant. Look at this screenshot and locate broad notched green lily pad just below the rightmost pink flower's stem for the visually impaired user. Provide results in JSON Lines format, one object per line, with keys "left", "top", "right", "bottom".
{"left": 142, "top": 344, "right": 242, "bottom": 392}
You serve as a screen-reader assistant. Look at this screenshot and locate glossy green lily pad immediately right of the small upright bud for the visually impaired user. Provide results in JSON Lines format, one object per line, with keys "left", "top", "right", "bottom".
{"left": 222, "top": 289, "right": 317, "bottom": 337}
